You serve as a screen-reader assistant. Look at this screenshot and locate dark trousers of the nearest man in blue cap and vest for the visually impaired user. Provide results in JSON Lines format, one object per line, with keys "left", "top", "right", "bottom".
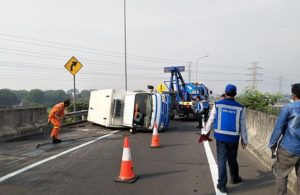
{"left": 217, "top": 141, "right": 239, "bottom": 188}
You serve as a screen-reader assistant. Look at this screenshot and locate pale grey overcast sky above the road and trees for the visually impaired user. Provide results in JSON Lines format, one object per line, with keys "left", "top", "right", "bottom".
{"left": 0, "top": 0, "right": 300, "bottom": 93}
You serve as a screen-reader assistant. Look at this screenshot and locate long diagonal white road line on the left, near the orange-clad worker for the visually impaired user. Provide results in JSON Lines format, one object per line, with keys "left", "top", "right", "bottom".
{"left": 0, "top": 131, "right": 119, "bottom": 183}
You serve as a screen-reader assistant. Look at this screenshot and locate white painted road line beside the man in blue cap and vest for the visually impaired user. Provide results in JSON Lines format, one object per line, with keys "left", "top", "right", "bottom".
{"left": 203, "top": 141, "right": 226, "bottom": 195}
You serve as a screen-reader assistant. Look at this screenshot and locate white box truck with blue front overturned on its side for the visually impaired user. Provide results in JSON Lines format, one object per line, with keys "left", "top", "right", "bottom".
{"left": 88, "top": 89, "right": 171, "bottom": 131}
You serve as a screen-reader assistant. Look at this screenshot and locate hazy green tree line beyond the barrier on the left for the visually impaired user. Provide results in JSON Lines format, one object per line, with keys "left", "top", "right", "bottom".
{"left": 0, "top": 89, "right": 90, "bottom": 110}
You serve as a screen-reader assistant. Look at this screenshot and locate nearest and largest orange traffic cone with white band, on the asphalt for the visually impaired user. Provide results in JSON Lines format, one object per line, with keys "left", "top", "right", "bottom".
{"left": 115, "top": 136, "right": 138, "bottom": 183}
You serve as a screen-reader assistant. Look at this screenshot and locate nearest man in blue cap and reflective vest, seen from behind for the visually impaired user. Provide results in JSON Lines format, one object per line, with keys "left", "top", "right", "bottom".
{"left": 202, "top": 84, "right": 248, "bottom": 193}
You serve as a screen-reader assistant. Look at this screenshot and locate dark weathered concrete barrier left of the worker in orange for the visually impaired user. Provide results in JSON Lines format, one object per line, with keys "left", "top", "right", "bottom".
{"left": 0, "top": 108, "right": 48, "bottom": 138}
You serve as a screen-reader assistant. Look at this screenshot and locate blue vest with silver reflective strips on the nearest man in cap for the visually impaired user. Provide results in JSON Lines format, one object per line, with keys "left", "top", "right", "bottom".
{"left": 214, "top": 99, "right": 244, "bottom": 142}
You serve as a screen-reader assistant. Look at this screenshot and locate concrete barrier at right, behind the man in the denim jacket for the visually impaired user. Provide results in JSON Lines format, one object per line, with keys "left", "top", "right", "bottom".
{"left": 246, "top": 109, "right": 297, "bottom": 194}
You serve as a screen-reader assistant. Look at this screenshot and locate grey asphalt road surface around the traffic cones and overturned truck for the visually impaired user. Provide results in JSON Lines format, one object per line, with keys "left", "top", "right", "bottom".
{"left": 0, "top": 121, "right": 275, "bottom": 195}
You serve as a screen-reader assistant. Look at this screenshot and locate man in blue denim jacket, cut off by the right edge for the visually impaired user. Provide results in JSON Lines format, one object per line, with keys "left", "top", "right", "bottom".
{"left": 268, "top": 83, "right": 300, "bottom": 195}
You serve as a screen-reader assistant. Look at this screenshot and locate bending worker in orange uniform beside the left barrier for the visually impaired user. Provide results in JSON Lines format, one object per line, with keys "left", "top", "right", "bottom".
{"left": 48, "top": 100, "right": 70, "bottom": 144}
